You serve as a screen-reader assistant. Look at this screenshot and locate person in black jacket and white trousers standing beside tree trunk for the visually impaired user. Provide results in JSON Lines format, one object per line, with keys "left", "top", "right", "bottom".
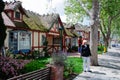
{"left": 81, "top": 40, "right": 92, "bottom": 72}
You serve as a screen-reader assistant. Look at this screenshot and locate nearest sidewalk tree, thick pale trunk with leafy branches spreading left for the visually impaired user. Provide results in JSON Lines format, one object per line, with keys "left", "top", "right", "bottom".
{"left": 65, "top": 0, "right": 100, "bottom": 66}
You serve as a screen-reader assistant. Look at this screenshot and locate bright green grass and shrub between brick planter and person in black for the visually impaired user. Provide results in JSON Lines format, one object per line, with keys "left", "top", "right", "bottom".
{"left": 64, "top": 57, "right": 83, "bottom": 78}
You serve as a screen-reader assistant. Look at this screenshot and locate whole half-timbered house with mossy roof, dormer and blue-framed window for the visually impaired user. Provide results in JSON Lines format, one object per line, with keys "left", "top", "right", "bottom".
{"left": 2, "top": 1, "right": 66, "bottom": 53}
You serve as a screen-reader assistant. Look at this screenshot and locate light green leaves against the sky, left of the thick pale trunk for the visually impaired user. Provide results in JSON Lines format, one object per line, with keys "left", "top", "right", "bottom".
{"left": 65, "top": 0, "right": 92, "bottom": 23}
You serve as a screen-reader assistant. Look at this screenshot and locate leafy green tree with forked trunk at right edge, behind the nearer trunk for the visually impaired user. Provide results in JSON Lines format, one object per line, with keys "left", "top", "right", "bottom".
{"left": 99, "top": 0, "right": 120, "bottom": 48}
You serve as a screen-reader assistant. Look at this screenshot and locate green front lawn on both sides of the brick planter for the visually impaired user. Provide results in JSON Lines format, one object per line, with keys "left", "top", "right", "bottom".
{"left": 21, "top": 57, "right": 83, "bottom": 78}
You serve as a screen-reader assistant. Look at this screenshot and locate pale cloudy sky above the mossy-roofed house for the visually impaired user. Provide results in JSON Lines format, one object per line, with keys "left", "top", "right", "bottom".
{"left": 3, "top": 0, "right": 66, "bottom": 22}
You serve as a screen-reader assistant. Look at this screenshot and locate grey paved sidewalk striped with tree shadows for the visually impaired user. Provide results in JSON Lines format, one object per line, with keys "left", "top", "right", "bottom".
{"left": 73, "top": 48, "right": 120, "bottom": 80}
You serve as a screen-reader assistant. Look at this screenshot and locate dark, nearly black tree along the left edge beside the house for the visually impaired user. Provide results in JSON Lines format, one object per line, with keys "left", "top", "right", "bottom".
{"left": 0, "top": 0, "right": 7, "bottom": 53}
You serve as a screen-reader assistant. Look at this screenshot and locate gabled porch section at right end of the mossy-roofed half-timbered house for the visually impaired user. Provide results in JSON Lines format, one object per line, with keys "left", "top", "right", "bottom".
{"left": 40, "top": 14, "right": 65, "bottom": 52}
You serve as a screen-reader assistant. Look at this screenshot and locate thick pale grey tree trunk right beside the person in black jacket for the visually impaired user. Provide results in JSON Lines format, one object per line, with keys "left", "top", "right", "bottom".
{"left": 90, "top": 0, "right": 100, "bottom": 66}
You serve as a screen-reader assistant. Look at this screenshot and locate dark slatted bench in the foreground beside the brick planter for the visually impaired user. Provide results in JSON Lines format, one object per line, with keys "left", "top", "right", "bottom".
{"left": 7, "top": 67, "right": 51, "bottom": 80}
